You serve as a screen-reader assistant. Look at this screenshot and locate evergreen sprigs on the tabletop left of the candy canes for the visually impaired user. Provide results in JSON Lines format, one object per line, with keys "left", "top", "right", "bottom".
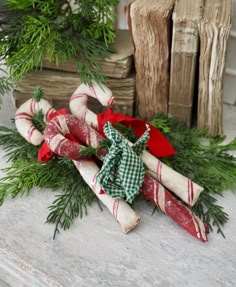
{"left": 0, "top": 153, "right": 95, "bottom": 238}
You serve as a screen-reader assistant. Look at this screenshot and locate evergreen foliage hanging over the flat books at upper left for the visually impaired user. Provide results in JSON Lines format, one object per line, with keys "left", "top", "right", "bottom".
{"left": 0, "top": 0, "right": 119, "bottom": 100}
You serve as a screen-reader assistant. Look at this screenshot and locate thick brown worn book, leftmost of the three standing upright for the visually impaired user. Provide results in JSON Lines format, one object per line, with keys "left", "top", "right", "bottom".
{"left": 127, "top": 0, "right": 174, "bottom": 120}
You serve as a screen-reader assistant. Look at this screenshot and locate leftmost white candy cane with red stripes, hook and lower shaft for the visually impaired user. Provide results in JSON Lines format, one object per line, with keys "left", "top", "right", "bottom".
{"left": 15, "top": 99, "right": 140, "bottom": 233}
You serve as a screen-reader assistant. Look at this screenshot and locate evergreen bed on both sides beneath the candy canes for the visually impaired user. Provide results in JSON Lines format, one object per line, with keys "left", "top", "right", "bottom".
{"left": 0, "top": 114, "right": 236, "bottom": 240}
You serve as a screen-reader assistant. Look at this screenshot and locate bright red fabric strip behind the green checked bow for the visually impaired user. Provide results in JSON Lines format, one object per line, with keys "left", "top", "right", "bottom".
{"left": 98, "top": 108, "right": 176, "bottom": 157}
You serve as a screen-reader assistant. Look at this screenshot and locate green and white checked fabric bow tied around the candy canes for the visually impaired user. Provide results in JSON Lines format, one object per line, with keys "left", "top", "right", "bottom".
{"left": 97, "top": 122, "right": 149, "bottom": 203}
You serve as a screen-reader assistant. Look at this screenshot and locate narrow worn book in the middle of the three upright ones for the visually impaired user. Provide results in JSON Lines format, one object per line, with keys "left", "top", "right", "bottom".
{"left": 168, "top": 0, "right": 204, "bottom": 126}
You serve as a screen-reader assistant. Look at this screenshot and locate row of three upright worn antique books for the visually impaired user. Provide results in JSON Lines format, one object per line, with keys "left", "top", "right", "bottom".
{"left": 128, "top": 0, "right": 232, "bottom": 136}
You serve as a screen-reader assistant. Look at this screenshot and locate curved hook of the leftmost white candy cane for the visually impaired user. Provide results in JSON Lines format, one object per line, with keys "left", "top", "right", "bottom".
{"left": 15, "top": 99, "right": 56, "bottom": 145}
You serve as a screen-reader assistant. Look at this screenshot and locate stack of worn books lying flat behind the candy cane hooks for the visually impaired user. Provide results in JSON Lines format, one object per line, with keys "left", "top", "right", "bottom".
{"left": 14, "top": 30, "right": 135, "bottom": 115}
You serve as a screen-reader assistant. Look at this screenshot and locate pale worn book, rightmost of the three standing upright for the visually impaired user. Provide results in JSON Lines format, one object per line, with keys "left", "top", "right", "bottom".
{"left": 197, "top": 0, "right": 232, "bottom": 137}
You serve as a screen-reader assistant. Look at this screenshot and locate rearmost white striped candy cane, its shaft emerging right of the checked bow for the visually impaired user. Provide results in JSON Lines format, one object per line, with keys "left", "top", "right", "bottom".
{"left": 70, "top": 83, "right": 203, "bottom": 206}
